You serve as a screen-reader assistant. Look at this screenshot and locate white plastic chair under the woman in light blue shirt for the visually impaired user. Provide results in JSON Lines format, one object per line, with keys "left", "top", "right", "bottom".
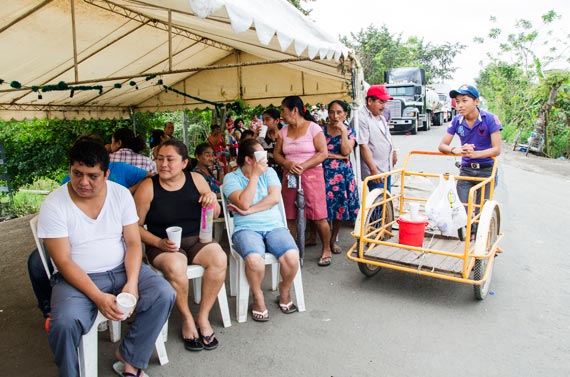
{"left": 222, "top": 195, "right": 305, "bottom": 323}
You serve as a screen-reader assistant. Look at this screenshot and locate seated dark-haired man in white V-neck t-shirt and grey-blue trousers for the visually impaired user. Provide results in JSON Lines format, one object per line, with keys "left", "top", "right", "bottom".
{"left": 38, "top": 139, "right": 175, "bottom": 376}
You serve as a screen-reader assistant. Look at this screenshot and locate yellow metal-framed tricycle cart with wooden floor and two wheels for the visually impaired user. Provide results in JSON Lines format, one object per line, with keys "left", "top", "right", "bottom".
{"left": 347, "top": 151, "right": 503, "bottom": 300}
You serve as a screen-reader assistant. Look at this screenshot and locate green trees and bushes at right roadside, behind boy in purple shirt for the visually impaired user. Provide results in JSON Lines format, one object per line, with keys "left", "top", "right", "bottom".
{"left": 477, "top": 11, "right": 570, "bottom": 158}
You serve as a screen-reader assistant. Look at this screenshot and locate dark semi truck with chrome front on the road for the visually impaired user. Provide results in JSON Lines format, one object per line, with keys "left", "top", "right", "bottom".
{"left": 384, "top": 67, "right": 443, "bottom": 135}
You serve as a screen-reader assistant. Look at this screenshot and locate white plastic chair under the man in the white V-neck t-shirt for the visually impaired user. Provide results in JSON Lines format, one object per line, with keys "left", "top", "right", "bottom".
{"left": 30, "top": 216, "right": 168, "bottom": 377}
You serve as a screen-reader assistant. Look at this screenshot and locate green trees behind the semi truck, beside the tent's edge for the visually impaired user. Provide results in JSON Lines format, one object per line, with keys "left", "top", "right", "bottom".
{"left": 341, "top": 25, "right": 464, "bottom": 84}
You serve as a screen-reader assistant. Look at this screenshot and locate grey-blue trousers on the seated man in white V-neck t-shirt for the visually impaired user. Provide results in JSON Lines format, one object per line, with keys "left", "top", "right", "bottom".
{"left": 48, "top": 264, "right": 176, "bottom": 377}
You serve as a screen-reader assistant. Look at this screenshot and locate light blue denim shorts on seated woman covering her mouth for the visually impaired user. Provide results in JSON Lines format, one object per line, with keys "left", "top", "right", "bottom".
{"left": 232, "top": 228, "right": 299, "bottom": 259}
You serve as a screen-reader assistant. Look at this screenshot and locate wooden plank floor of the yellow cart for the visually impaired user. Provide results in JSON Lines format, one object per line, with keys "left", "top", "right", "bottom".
{"left": 364, "top": 231, "right": 465, "bottom": 277}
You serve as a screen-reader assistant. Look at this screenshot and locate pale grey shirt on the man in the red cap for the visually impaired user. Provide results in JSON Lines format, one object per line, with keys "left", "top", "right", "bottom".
{"left": 352, "top": 106, "right": 394, "bottom": 180}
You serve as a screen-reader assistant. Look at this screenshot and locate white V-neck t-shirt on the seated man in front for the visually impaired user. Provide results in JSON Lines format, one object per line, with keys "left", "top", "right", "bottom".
{"left": 38, "top": 181, "right": 138, "bottom": 274}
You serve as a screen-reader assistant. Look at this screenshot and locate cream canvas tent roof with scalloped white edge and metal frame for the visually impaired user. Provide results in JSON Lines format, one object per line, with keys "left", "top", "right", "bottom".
{"left": 0, "top": 0, "right": 357, "bottom": 119}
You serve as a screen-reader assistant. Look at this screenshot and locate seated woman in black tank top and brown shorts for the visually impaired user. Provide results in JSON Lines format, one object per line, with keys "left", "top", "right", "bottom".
{"left": 135, "top": 139, "right": 227, "bottom": 351}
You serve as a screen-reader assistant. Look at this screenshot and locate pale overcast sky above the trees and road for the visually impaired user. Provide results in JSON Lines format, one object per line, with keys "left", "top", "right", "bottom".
{"left": 304, "top": 0, "right": 570, "bottom": 87}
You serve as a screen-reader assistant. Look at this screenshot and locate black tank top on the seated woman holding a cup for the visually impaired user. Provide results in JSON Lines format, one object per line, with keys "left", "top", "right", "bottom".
{"left": 146, "top": 171, "right": 202, "bottom": 238}
